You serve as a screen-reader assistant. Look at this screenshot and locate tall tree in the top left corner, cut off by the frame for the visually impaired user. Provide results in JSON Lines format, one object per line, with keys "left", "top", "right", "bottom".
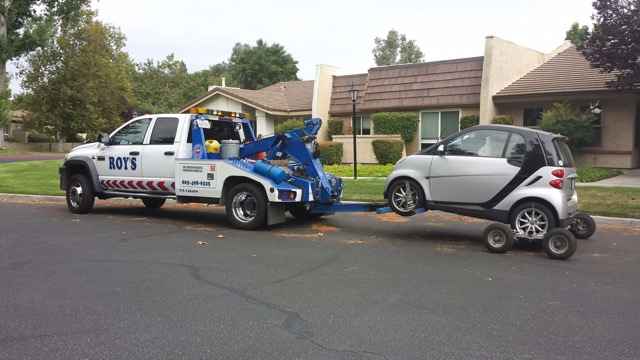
{"left": 0, "top": 0, "right": 89, "bottom": 146}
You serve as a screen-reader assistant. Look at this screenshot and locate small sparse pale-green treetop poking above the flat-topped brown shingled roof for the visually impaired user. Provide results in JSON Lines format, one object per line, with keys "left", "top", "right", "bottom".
{"left": 373, "top": 30, "right": 424, "bottom": 66}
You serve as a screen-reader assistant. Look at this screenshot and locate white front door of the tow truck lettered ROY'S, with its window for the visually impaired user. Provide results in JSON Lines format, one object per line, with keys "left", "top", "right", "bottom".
{"left": 94, "top": 118, "right": 151, "bottom": 191}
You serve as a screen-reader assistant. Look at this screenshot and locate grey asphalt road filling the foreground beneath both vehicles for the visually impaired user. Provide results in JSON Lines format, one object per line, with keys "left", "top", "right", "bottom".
{"left": 0, "top": 198, "right": 640, "bottom": 360}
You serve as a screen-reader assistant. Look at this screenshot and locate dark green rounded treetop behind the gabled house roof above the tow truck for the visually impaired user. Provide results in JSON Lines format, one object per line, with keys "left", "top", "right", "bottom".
{"left": 229, "top": 39, "right": 298, "bottom": 90}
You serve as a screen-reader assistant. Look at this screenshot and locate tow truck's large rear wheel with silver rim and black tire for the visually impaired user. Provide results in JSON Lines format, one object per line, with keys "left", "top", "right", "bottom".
{"left": 225, "top": 183, "right": 267, "bottom": 230}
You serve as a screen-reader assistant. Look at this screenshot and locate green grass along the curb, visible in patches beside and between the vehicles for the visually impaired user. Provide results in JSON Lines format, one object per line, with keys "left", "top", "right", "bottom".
{"left": 0, "top": 160, "right": 640, "bottom": 218}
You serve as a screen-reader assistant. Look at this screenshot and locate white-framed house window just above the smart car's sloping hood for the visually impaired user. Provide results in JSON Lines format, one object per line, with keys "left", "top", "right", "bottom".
{"left": 420, "top": 110, "right": 460, "bottom": 149}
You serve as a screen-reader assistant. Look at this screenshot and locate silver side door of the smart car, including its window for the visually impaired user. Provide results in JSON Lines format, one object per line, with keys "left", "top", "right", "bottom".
{"left": 429, "top": 129, "right": 524, "bottom": 205}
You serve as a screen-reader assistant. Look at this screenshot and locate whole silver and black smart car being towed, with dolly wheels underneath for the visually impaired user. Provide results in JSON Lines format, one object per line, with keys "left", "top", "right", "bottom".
{"left": 384, "top": 125, "right": 595, "bottom": 259}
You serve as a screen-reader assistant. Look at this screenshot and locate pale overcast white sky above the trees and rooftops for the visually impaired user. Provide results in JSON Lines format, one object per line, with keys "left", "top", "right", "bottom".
{"left": 10, "top": 0, "right": 592, "bottom": 91}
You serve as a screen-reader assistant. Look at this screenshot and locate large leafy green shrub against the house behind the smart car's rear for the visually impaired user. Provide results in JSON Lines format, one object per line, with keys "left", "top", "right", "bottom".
{"left": 540, "top": 102, "right": 595, "bottom": 149}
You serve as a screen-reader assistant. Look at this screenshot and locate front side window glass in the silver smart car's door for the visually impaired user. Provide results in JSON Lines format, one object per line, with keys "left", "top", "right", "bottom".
{"left": 446, "top": 130, "right": 509, "bottom": 157}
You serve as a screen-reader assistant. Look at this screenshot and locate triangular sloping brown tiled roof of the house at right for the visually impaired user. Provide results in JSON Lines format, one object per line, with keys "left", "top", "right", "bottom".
{"left": 494, "top": 46, "right": 615, "bottom": 98}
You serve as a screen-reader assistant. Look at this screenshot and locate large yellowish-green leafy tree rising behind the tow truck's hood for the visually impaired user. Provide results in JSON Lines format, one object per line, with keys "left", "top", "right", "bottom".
{"left": 21, "top": 12, "right": 133, "bottom": 141}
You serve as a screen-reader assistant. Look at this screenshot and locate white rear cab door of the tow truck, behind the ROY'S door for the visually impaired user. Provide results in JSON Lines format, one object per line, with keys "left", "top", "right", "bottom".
{"left": 142, "top": 117, "right": 179, "bottom": 193}
